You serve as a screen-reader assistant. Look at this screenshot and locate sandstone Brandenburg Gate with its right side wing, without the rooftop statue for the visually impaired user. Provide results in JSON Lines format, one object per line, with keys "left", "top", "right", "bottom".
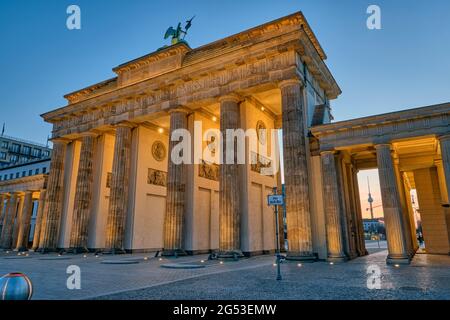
{"left": 9, "top": 12, "right": 450, "bottom": 263}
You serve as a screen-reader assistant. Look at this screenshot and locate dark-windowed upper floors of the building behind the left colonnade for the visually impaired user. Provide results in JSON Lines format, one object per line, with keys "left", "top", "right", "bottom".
{"left": 0, "top": 135, "right": 52, "bottom": 168}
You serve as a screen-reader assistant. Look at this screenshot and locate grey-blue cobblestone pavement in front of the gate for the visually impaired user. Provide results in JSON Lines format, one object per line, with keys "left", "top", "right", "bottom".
{"left": 0, "top": 249, "right": 450, "bottom": 300}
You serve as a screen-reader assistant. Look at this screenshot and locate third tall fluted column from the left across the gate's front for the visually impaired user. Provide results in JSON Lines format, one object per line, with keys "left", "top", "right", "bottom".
{"left": 105, "top": 123, "right": 134, "bottom": 254}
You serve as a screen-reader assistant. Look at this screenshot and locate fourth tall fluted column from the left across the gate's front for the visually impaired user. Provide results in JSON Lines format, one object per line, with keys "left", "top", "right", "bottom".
{"left": 163, "top": 110, "right": 188, "bottom": 256}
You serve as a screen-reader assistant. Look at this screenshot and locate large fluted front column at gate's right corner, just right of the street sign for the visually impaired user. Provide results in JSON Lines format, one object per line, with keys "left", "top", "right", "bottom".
{"left": 280, "top": 80, "right": 315, "bottom": 260}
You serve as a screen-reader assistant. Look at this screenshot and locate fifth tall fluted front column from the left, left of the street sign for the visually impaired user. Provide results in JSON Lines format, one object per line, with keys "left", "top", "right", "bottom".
{"left": 219, "top": 95, "right": 242, "bottom": 257}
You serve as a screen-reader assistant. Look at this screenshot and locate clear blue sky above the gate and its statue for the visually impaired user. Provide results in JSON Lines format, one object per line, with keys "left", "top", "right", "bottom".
{"left": 0, "top": 0, "right": 450, "bottom": 142}
